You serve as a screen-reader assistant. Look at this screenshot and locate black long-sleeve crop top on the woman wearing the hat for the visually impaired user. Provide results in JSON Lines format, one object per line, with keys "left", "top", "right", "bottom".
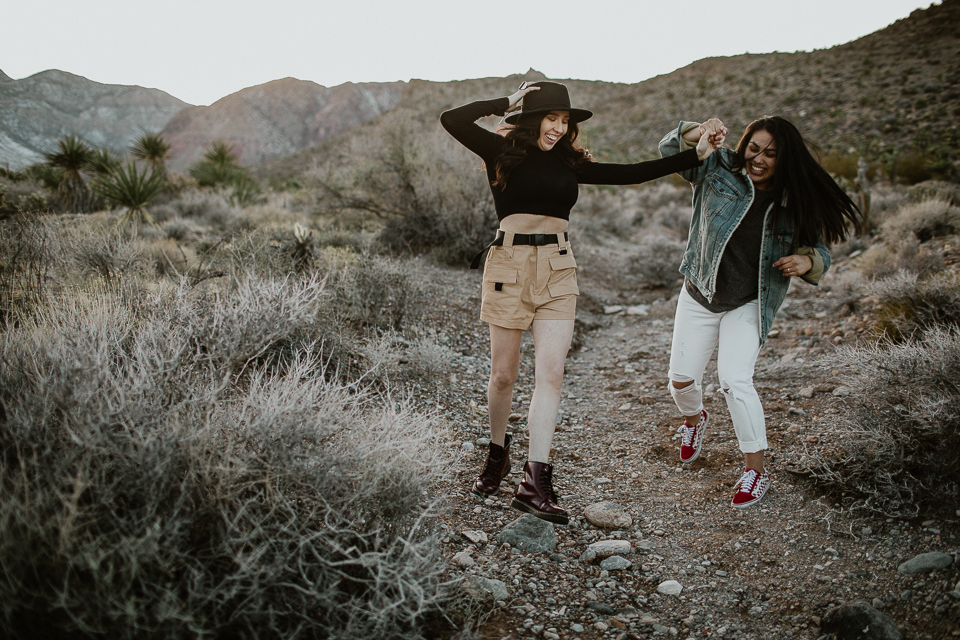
{"left": 440, "top": 98, "right": 701, "bottom": 220}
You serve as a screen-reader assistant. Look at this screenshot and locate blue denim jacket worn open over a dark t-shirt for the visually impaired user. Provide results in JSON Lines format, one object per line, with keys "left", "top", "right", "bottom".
{"left": 660, "top": 122, "right": 830, "bottom": 346}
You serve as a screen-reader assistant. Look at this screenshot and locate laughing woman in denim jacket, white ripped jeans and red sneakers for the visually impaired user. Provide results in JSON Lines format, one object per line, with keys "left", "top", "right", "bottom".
{"left": 660, "top": 116, "right": 860, "bottom": 509}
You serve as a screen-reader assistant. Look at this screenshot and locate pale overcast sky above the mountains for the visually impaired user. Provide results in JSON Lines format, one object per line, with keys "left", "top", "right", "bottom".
{"left": 0, "top": 0, "right": 939, "bottom": 105}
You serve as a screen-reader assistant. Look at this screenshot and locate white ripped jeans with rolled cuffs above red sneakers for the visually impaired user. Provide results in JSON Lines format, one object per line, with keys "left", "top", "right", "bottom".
{"left": 669, "top": 287, "right": 767, "bottom": 453}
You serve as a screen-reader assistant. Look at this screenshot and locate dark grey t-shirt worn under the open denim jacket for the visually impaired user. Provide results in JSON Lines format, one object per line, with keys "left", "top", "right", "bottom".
{"left": 686, "top": 189, "right": 773, "bottom": 313}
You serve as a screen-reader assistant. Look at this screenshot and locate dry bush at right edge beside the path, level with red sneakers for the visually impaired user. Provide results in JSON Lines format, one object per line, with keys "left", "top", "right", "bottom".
{"left": 808, "top": 327, "right": 960, "bottom": 517}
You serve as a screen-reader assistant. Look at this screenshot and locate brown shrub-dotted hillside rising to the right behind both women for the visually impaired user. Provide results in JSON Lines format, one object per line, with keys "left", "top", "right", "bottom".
{"left": 260, "top": 0, "right": 960, "bottom": 178}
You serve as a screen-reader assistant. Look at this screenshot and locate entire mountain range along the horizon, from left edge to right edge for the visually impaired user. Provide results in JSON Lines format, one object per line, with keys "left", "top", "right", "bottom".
{"left": 0, "top": 0, "right": 960, "bottom": 172}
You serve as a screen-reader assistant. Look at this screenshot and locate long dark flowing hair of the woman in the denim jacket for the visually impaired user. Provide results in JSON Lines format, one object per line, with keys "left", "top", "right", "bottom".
{"left": 733, "top": 116, "right": 861, "bottom": 246}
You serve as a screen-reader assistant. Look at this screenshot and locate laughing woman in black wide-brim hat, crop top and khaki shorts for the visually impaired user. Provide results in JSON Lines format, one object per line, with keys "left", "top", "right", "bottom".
{"left": 440, "top": 81, "right": 715, "bottom": 524}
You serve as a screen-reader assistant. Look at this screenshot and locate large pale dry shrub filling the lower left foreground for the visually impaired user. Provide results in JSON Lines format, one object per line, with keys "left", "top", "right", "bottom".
{"left": 0, "top": 279, "right": 445, "bottom": 639}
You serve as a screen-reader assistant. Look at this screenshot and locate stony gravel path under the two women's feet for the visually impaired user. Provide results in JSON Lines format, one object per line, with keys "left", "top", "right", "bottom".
{"left": 422, "top": 246, "right": 960, "bottom": 640}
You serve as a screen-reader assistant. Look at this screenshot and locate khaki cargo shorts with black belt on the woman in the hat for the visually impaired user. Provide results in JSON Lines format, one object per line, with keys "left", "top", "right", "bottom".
{"left": 480, "top": 233, "right": 580, "bottom": 329}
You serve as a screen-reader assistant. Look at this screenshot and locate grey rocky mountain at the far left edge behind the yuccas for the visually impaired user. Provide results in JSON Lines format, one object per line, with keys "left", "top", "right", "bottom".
{"left": 0, "top": 70, "right": 188, "bottom": 169}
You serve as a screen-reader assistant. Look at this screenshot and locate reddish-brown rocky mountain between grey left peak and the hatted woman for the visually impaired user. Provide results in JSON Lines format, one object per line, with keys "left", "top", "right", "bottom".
{"left": 163, "top": 78, "right": 404, "bottom": 171}
